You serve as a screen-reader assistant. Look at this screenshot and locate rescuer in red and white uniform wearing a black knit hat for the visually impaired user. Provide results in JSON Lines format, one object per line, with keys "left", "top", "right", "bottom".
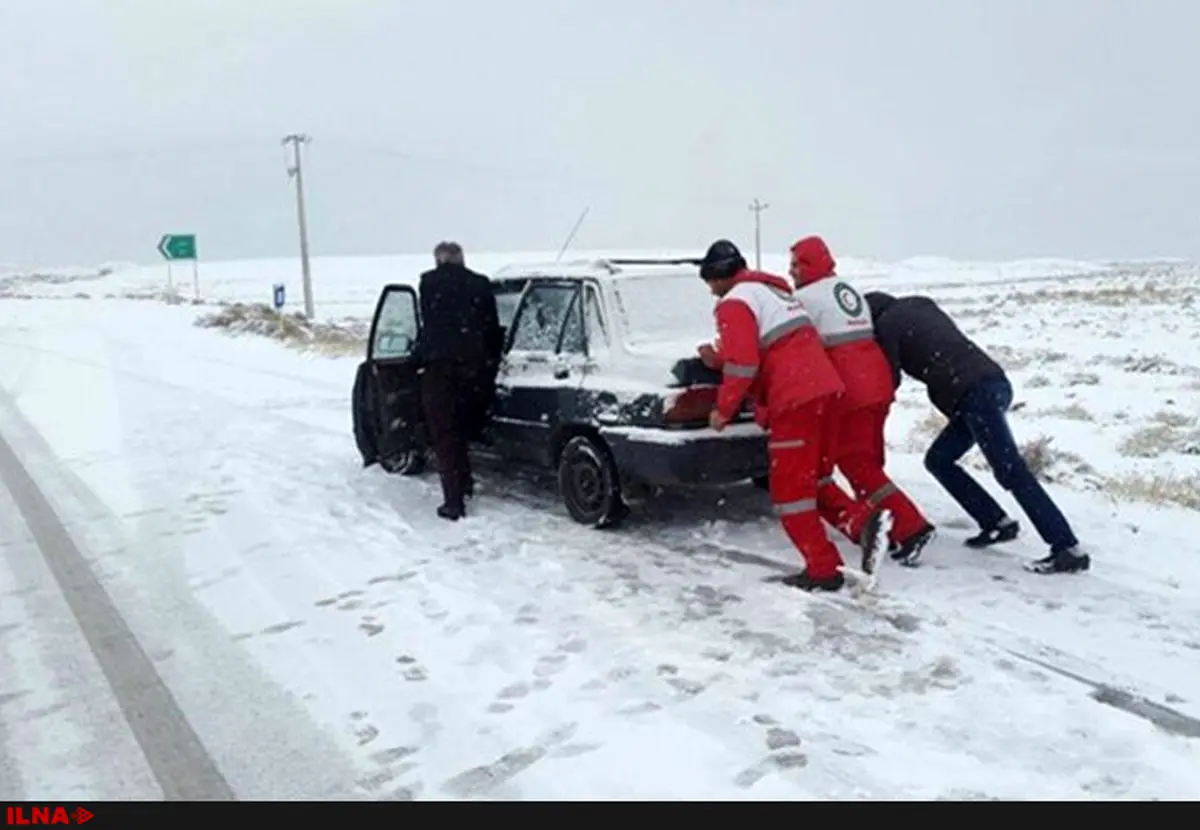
{"left": 700, "top": 240, "right": 890, "bottom": 591}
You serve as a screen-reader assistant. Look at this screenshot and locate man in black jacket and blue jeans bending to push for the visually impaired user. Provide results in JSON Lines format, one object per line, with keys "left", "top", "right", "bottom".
{"left": 866, "top": 291, "right": 1091, "bottom": 573}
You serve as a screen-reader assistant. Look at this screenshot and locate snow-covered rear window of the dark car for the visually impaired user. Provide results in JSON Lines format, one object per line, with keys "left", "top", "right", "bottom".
{"left": 613, "top": 273, "right": 715, "bottom": 345}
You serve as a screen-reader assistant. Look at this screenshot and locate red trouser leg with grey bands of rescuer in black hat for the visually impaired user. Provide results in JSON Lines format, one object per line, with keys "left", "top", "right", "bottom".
{"left": 767, "top": 396, "right": 845, "bottom": 579}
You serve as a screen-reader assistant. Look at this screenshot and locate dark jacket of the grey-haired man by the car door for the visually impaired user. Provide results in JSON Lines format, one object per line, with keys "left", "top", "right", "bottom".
{"left": 418, "top": 265, "right": 504, "bottom": 366}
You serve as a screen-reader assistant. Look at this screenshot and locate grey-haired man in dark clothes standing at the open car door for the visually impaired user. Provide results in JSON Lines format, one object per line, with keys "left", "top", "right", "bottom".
{"left": 418, "top": 242, "right": 503, "bottom": 521}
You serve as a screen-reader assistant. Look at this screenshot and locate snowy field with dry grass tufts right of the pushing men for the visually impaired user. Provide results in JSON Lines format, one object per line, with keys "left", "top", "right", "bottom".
{"left": 896, "top": 264, "right": 1200, "bottom": 510}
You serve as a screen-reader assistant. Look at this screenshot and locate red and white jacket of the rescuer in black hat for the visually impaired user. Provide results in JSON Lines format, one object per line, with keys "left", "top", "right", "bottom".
{"left": 716, "top": 270, "right": 840, "bottom": 427}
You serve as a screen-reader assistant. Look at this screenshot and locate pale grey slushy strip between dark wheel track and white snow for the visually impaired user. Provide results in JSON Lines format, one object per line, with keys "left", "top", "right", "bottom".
{"left": 0, "top": 362, "right": 359, "bottom": 799}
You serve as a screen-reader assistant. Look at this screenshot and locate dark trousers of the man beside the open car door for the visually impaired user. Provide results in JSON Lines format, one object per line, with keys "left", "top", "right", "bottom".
{"left": 421, "top": 360, "right": 492, "bottom": 507}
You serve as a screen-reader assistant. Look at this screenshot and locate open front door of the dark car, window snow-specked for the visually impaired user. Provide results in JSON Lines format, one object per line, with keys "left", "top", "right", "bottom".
{"left": 354, "top": 284, "right": 425, "bottom": 474}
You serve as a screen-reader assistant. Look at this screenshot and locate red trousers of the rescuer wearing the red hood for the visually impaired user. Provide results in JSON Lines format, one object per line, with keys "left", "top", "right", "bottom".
{"left": 822, "top": 404, "right": 929, "bottom": 543}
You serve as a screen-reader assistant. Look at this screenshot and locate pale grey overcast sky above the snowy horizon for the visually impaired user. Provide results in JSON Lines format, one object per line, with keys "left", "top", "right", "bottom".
{"left": 0, "top": 0, "right": 1200, "bottom": 265}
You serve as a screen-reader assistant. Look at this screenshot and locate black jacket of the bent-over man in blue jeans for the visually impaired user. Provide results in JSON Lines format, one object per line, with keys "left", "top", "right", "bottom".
{"left": 866, "top": 291, "right": 1004, "bottom": 417}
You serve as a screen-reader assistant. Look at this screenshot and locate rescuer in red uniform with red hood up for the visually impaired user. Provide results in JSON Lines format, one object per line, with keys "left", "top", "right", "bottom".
{"left": 790, "top": 236, "right": 935, "bottom": 565}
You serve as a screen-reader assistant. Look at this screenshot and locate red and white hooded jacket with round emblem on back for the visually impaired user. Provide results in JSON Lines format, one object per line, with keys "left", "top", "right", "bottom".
{"left": 792, "top": 236, "right": 895, "bottom": 410}
